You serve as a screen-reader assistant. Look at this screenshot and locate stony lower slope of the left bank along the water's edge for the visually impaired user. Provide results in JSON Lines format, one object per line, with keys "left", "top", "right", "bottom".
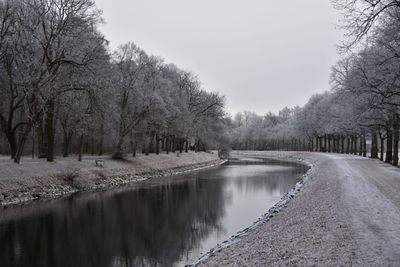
{"left": 0, "top": 155, "right": 226, "bottom": 207}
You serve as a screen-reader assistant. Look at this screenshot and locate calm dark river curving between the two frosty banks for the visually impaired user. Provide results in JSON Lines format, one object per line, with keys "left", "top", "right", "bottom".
{"left": 0, "top": 159, "right": 306, "bottom": 266}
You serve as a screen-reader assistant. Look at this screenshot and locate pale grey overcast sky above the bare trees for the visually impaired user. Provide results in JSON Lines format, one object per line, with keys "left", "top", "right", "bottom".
{"left": 96, "top": 0, "right": 342, "bottom": 114}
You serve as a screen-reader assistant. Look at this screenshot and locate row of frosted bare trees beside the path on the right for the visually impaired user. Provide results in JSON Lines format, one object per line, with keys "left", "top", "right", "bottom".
{"left": 230, "top": 0, "right": 400, "bottom": 166}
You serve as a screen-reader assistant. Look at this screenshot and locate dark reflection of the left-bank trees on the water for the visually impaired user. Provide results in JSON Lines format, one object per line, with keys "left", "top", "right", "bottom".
{"left": 0, "top": 179, "right": 224, "bottom": 266}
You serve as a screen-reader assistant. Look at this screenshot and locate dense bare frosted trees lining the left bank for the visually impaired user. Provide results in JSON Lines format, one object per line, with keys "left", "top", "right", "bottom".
{"left": 0, "top": 0, "right": 225, "bottom": 163}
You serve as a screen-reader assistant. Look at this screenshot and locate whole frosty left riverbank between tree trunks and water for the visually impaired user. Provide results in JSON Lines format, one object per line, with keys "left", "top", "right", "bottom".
{"left": 0, "top": 152, "right": 224, "bottom": 206}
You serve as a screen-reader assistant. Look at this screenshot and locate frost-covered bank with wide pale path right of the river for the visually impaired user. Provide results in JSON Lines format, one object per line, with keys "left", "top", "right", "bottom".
{"left": 200, "top": 152, "right": 400, "bottom": 266}
